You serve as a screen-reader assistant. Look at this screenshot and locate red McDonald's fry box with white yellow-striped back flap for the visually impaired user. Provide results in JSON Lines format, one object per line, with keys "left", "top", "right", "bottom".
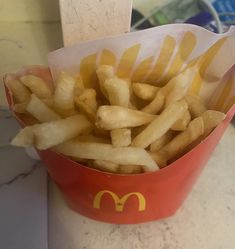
{"left": 4, "top": 25, "right": 235, "bottom": 224}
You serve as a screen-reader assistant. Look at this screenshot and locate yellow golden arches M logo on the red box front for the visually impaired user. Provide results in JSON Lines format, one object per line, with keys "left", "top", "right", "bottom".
{"left": 93, "top": 190, "right": 146, "bottom": 212}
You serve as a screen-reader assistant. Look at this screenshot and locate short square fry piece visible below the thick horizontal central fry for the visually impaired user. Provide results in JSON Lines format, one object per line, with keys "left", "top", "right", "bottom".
{"left": 110, "top": 128, "right": 131, "bottom": 147}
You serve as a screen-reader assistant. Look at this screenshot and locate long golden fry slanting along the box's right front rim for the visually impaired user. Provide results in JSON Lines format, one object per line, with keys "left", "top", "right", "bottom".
{"left": 153, "top": 117, "right": 204, "bottom": 167}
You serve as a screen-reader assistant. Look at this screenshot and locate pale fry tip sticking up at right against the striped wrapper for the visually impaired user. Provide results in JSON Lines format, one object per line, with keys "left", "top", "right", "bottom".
{"left": 161, "top": 68, "right": 195, "bottom": 106}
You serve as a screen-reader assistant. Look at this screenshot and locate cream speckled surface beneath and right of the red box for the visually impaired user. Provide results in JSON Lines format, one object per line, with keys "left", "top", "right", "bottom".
{"left": 49, "top": 123, "right": 235, "bottom": 249}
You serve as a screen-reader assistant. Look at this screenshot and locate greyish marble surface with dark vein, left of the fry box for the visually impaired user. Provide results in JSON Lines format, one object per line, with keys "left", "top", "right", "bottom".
{"left": 0, "top": 110, "right": 48, "bottom": 249}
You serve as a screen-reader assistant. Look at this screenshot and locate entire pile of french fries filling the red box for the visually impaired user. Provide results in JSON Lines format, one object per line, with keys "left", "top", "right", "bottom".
{"left": 7, "top": 62, "right": 225, "bottom": 174}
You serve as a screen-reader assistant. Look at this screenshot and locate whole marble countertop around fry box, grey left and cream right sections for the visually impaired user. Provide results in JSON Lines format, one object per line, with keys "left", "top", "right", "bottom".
{"left": 0, "top": 106, "right": 235, "bottom": 249}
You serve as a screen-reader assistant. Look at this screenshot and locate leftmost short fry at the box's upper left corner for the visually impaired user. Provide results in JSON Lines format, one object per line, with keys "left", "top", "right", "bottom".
{"left": 6, "top": 80, "right": 30, "bottom": 104}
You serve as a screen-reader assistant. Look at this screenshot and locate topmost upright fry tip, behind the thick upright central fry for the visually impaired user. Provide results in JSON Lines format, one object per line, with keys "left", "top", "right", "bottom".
{"left": 96, "top": 65, "right": 114, "bottom": 99}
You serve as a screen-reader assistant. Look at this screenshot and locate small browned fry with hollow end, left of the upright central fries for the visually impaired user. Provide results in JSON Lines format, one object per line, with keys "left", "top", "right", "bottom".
{"left": 74, "top": 88, "right": 98, "bottom": 121}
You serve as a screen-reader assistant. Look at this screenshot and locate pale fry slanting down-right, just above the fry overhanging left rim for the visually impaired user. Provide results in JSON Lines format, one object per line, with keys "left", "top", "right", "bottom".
{"left": 26, "top": 94, "right": 61, "bottom": 122}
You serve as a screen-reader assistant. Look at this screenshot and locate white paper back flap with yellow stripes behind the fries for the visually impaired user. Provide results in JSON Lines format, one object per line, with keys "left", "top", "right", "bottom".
{"left": 48, "top": 24, "right": 235, "bottom": 111}
